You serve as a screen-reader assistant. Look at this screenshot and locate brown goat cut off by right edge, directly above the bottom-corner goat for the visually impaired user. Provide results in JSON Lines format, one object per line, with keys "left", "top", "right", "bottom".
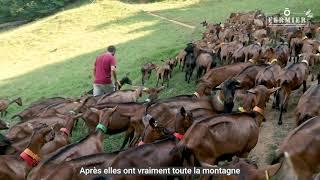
{"left": 295, "top": 84, "right": 320, "bottom": 126}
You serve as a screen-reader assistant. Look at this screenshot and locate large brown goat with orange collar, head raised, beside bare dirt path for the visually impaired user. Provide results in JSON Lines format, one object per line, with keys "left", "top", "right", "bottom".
{"left": 179, "top": 86, "right": 276, "bottom": 165}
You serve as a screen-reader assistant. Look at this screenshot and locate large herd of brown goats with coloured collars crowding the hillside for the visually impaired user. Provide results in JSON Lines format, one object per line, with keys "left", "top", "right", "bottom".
{"left": 0, "top": 10, "right": 320, "bottom": 180}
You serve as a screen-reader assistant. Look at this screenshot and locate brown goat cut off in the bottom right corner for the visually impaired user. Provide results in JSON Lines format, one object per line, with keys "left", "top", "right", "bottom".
{"left": 273, "top": 116, "right": 320, "bottom": 180}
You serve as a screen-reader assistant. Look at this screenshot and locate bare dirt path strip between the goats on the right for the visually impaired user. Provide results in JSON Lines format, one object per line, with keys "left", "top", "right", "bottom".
{"left": 249, "top": 79, "right": 315, "bottom": 167}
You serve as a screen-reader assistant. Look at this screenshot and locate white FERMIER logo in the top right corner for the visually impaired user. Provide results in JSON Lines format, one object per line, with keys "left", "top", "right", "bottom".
{"left": 266, "top": 8, "right": 313, "bottom": 27}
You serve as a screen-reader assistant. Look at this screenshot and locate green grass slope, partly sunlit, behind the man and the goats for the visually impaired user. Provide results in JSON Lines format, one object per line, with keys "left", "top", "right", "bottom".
{"left": 0, "top": 0, "right": 320, "bottom": 150}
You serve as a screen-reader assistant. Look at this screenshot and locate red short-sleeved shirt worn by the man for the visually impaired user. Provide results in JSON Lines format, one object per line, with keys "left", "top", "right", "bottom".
{"left": 94, "top": 52, "right": 116, "bottom": 84}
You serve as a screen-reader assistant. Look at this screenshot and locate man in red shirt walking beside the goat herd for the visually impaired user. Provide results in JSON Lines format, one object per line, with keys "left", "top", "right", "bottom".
{"left": 93, "top": 46, "right": 120, "bottom": 96}
